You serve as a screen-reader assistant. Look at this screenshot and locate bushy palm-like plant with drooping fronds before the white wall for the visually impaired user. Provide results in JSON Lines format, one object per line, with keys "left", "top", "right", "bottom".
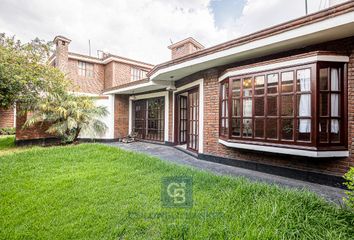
{"left": 24, "top": 94, "right": 108, "bottom": 143}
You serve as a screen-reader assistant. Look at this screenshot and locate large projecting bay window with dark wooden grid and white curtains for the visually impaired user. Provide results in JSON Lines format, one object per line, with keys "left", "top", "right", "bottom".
{"left": 220, "top": 62, "right": 347, "bottom": 150}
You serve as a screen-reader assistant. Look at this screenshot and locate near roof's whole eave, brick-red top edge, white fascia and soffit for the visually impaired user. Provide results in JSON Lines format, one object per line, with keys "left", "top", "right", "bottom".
{"left": 148, "top": 1, "right": 354, "bottom": 81}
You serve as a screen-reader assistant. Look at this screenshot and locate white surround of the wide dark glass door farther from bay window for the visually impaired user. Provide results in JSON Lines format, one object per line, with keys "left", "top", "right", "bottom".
{"left": 129, "top": 91, "right": 170, "bottom": 142}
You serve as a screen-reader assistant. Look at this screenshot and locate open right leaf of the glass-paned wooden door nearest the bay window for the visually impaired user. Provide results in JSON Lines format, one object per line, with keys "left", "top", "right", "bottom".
{"left": 187, "top": 89, "right": 199, "bottom": 151}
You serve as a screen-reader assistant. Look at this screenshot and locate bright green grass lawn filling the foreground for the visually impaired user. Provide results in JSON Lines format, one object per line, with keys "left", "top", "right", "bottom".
{"left": 0, "top": 140, "right": 354, "bottom": 240}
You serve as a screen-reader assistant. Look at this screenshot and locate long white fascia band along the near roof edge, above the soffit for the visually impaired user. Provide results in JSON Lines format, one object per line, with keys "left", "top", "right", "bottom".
{"left": 150, "top": 11, "right": 354, "bottom": 80}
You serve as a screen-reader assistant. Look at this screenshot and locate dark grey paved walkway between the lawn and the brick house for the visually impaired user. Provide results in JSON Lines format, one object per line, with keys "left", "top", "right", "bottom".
{"left": 106, "top": 142, "right": 345, "bottom": 204}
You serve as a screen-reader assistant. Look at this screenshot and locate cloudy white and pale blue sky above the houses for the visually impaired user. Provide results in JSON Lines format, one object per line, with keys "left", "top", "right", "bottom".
{"left": 0, "top": 0, "right": 346, "bottom": 64}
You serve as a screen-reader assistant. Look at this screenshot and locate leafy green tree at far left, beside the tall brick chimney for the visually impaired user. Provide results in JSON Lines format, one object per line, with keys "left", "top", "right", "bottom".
{"left": 0, "top": 33, "right": 70, "bottom": 111}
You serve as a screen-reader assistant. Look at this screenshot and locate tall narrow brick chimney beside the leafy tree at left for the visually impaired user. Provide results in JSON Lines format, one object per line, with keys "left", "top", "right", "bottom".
{"left": 53, "top": 36, "right": 71, "bottom": 73}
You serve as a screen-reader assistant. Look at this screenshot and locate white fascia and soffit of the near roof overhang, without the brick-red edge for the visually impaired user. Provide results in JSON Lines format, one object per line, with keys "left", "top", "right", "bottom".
{"left": 150, "top": 11, "right": 354, "bottom": 81}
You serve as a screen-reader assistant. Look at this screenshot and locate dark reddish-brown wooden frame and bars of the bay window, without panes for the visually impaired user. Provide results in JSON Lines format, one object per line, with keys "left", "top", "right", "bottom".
{"left": 219, "top": 62, "right": 348, "bottom": 150}
